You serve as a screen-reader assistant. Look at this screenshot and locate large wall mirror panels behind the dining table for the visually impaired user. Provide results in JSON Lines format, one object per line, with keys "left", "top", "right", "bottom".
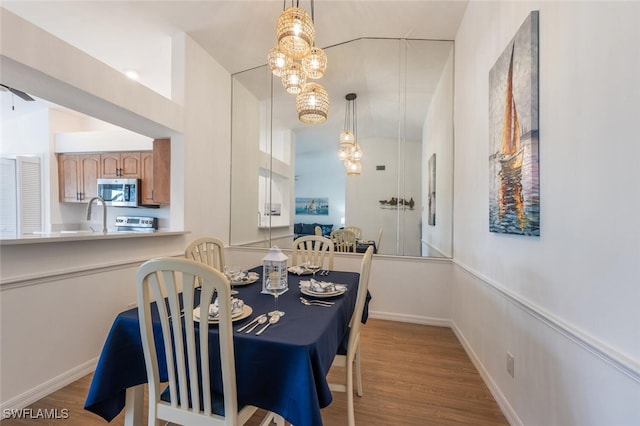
{"left": 229, "top": 39, "right": 454, "bottom": 257}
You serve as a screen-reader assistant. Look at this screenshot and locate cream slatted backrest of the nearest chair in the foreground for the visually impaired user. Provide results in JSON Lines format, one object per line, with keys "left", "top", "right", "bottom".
{"left": 137, "top": 257, "right": 238, "bottom": 425}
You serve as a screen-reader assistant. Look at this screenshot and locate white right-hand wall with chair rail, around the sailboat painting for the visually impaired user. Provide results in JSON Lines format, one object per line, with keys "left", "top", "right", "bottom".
{"left": 453, "top": 2, "right": 640, "bottom": 425}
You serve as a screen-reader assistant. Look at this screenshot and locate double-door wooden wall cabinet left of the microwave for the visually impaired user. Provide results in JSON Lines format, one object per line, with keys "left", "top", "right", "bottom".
{"left": 58, "top": 154, "right": 100, "bottom": 203}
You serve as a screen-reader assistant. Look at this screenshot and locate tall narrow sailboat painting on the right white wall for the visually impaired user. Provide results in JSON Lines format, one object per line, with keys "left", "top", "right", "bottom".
{"left": 489, "top": 11, "right": 540, "bottom": 236}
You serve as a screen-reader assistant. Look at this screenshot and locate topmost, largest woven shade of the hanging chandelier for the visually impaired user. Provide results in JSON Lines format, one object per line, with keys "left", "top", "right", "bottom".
{"left": 276, "top": 7, "right": 316, "bottom": 59}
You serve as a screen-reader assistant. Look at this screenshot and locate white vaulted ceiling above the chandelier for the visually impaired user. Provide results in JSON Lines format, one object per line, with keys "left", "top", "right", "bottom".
{"left": 0, "top": 0, "right": 467, "bottom": 140}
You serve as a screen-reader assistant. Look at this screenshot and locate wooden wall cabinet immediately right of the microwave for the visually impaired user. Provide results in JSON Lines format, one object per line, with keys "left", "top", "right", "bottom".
{"left": 140, "top": 139, "right": 171, "bottom": 205}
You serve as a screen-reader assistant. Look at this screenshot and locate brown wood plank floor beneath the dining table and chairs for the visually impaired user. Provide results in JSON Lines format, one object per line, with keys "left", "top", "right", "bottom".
{"left": 0, "top": 319, "right": 509, "bottom": 426}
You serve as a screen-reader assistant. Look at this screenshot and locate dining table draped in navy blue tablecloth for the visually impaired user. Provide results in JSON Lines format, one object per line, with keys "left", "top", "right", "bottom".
{"left": 84, "top": 266, "right": 371, "bottom": 426}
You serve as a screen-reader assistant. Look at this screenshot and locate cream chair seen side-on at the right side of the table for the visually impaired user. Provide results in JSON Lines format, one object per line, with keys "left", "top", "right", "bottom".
{"left": 329, "top": 246, "right": 373, "bottom": 426}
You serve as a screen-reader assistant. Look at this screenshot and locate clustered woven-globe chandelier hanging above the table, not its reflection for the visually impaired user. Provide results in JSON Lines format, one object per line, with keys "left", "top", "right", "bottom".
{"left": 267, "top": 0, "right": 329, "bottom": 124}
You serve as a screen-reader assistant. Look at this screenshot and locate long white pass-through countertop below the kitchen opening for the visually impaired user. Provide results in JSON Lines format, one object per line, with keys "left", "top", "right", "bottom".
{"left": 0, "top": 229, "right": 191, "bottom": 246}
